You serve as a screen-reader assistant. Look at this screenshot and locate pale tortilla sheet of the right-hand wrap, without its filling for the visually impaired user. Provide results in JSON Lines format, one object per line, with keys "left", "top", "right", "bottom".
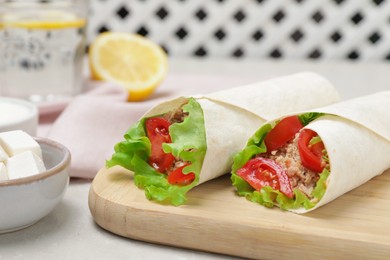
{"left": 235, "top": 91, "right": 390, "bottom": 213}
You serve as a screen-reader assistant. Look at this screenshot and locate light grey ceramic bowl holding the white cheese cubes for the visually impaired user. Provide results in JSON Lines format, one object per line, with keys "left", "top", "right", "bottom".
{"left": 0, "top": 138, "right": 70, "bottom": 233}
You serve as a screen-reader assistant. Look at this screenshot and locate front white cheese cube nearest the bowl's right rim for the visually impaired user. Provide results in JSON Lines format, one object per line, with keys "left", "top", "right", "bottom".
{"left": 7, "top": 151, "right": 46, "bottom": 179}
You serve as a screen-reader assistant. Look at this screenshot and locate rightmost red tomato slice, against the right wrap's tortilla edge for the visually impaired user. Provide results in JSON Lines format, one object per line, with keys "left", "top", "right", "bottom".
{"left": 298, "top": 129, "right": 325, "bottom": 173}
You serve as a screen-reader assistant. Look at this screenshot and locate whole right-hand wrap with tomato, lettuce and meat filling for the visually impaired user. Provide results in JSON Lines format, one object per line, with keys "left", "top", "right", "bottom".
{"left": 231, "top": 91, "right": 390, "bottom": 213}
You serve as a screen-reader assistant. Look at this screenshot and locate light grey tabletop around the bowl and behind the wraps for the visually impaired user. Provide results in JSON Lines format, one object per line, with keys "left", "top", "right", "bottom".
{"left": 0, "top": 59, "right": 390, "bottom": 259}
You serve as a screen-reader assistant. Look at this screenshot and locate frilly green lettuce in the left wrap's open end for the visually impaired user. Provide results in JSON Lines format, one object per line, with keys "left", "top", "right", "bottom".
{"left": 106, "top": 98, "right": 207, "bottom": 206}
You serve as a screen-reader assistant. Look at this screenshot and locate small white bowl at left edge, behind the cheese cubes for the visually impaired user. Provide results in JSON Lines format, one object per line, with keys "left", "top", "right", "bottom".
{"left": 0, "top": 97, "right": 39, "bottom": 136}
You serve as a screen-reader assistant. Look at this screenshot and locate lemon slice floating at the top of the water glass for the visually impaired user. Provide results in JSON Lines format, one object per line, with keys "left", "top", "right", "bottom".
{"left": 3, "top": 10, "right": 86, "bottom": 30}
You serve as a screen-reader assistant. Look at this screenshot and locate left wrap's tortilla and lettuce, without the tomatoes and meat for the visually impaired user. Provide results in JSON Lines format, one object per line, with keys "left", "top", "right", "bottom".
{"left": 107, "top": 72, "right": 339, "bottom": 205}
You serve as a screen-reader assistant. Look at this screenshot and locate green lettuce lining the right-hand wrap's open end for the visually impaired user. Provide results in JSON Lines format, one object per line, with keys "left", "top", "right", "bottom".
{"left": 230, "top": 113, "right": 330, "bottom": 210}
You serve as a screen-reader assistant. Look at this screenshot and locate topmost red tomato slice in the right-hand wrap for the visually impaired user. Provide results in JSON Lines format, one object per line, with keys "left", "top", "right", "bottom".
{"left": 264, "top": 116, "right": 303, "bottom": 152}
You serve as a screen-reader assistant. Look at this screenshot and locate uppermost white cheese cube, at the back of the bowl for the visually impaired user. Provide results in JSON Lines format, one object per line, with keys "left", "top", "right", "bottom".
{"left": 0, "top": 130, "right": 42, "bottom": 158}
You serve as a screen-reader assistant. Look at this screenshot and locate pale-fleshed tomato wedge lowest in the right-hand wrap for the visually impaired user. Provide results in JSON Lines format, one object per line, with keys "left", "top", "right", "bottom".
{"left": 237, "top": 157, "right": 294, "bottom": 198}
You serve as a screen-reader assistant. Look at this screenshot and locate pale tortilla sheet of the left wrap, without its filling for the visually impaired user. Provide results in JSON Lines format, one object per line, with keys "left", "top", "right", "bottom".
{"left": 108, "top": 72, "right": 340, "bottom": 205}
